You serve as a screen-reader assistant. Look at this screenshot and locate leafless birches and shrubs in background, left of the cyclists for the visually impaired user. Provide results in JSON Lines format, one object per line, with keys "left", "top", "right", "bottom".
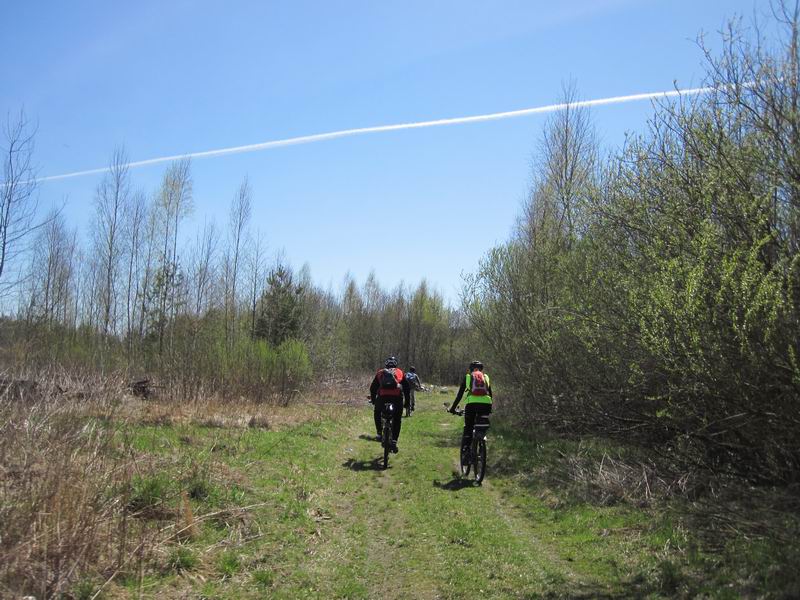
{"left": 0, "top": 138, "right": 476, "bottom": 400}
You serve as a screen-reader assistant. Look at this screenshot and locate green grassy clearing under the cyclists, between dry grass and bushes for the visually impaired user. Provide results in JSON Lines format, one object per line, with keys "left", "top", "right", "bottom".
{"left": 7, "top": 386, "right": 800, "bottom": 599}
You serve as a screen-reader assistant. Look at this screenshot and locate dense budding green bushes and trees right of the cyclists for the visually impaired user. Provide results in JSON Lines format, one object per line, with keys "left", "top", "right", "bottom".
{"left": 465, "top": 5, "right": 800, "bottom": 481}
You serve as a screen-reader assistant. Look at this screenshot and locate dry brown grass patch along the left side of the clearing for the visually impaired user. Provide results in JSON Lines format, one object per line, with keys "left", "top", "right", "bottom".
{"left": 0, "top": 373, "right": 340, "bottom": 598}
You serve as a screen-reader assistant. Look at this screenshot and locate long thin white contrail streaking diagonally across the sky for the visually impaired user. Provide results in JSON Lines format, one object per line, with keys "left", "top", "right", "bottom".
{"left": 34, "top": 87, "right": 715, "bottom": 183}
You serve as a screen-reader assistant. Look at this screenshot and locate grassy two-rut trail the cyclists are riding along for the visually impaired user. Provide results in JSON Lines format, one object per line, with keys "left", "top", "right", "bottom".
{"left": 290, "top": 395, "right": 620, "bottom": 598}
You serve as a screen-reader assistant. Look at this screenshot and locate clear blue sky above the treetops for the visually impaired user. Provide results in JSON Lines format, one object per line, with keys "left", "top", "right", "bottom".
{"left": 0, "top": 0, "right": 768, "bottom": 302}
